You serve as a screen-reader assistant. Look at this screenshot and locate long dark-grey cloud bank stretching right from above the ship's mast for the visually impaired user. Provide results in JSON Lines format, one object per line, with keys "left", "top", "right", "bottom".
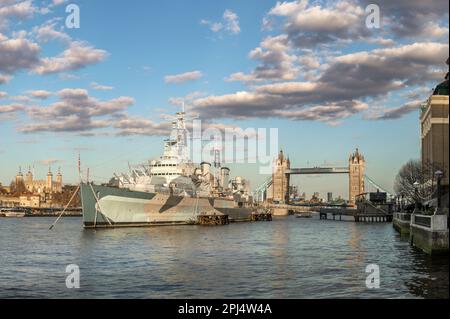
{"left": 192, "top": 42, "right": 448, "bottom": 123}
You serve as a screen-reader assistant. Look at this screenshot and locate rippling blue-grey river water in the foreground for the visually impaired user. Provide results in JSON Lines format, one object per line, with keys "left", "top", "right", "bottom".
{"left": 0, "top": 216, "right": 449, "bottom": 298}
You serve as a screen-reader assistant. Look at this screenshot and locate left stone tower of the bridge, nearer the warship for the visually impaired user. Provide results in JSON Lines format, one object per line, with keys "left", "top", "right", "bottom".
{"left": 272, "top": 151, "right": 291, "bottom": 203}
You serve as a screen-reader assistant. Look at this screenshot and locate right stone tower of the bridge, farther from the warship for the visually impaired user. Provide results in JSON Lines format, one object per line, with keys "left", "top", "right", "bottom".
{"left": 348, "top": 149, "right": 366, "bottom": 205}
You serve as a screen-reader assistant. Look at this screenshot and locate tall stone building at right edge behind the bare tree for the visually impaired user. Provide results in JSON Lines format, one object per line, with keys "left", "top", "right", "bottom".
{"left": 420, "top": 60, "right": 449, "bottom": 191}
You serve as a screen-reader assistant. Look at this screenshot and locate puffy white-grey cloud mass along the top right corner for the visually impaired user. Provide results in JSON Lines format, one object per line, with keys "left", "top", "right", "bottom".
{"left": 263, "top": 0, "right": 448, "bottom": 49}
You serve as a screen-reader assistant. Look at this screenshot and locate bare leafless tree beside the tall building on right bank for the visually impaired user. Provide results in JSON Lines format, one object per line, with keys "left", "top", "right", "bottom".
{"left": 394, "top": 160, "right": 436, "bottom": 203}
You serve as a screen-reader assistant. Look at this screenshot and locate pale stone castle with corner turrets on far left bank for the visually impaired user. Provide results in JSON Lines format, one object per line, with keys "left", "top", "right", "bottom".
{"left": 15, "top": 168, "right": 63, "bottom": 194}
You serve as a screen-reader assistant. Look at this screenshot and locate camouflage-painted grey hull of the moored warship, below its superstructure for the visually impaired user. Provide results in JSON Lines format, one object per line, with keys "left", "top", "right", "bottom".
{"left": 81, "top": 183, "right": 254, "bottom": 228}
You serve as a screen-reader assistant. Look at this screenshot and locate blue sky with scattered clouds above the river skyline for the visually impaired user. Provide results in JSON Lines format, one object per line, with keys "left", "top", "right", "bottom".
{"left": 0, "top": 0, "right": 448, "bottom": 200}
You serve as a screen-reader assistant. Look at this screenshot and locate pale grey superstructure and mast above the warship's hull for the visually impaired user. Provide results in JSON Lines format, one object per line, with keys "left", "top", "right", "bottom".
{"left": 115, "top": 107, "right": 249, "bottom": 198}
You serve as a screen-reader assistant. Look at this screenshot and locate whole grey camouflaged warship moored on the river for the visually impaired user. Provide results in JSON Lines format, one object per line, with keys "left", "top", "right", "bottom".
{"left": 80, "top": 107, "right": 255, "bottom": 228}
